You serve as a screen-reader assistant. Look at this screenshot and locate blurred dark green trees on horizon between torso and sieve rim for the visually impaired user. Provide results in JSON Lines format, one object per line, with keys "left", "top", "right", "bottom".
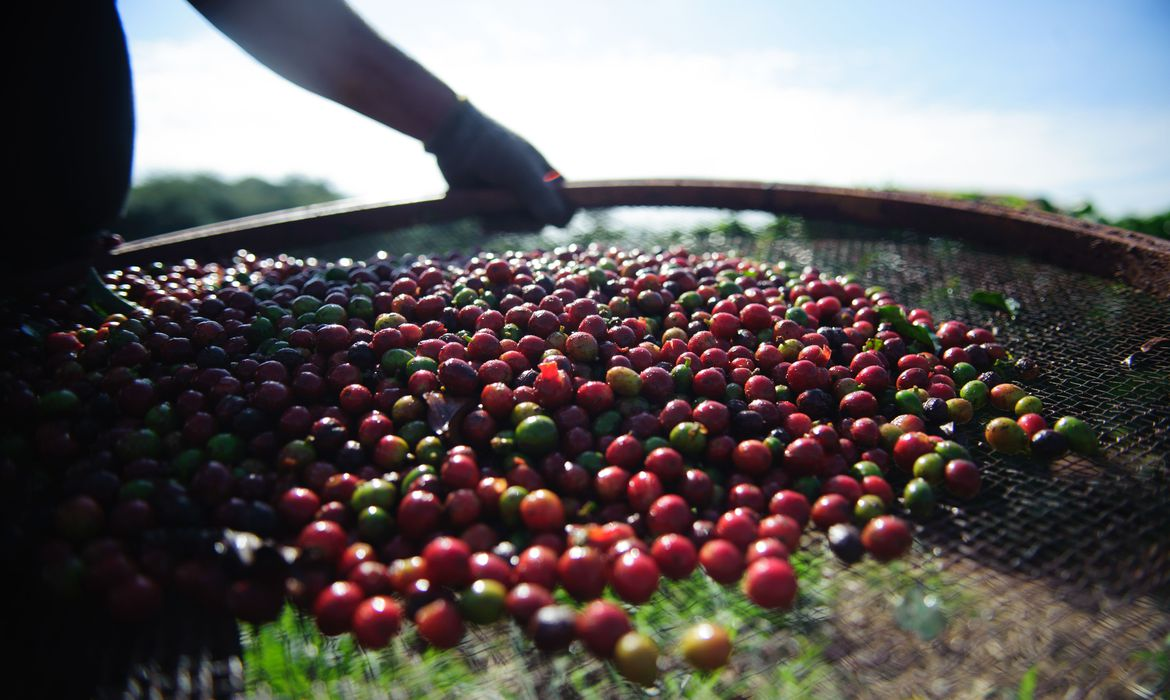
{"left": 116, "top": 174, "right": 340, "bottom": 240}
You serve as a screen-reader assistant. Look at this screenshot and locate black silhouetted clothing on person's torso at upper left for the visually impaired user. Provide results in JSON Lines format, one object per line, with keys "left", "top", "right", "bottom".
{"left": 13, "top": 0, "right": 135, "bottom": 259}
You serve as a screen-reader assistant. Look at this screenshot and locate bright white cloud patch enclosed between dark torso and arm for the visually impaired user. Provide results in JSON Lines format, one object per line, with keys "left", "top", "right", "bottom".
{"left": 133, "top": 33, "right": 443, "bottom": 198}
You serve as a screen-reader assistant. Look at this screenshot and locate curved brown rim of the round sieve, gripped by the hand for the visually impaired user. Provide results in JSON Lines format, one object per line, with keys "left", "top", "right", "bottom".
{"left": 103, "top": 179, "right": 1170, "bottom": 297}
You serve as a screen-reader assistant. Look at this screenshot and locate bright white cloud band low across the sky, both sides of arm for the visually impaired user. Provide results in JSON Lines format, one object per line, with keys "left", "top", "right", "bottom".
{"left": 132, "top": 30, "right": 1170, "bottom": 213}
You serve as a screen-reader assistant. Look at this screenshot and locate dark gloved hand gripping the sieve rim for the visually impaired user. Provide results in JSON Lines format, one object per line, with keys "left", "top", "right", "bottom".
{"left": 425, "top": 99, "right": 573, "bottom": 226}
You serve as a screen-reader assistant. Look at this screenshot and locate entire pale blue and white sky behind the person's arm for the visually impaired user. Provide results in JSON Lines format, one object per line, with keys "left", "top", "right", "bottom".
{"left": 118, "top": 0, "right": 1170, "bottom": 217}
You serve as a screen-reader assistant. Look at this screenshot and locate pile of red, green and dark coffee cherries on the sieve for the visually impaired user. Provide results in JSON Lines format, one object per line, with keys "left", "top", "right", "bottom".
{"left": 0, "top": 247, "right": 1076, "bottom": 682}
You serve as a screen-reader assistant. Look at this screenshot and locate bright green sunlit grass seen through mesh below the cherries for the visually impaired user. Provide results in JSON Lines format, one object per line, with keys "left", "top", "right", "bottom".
{"left": 243, "top": 542, "right": 976, "bottom": 698}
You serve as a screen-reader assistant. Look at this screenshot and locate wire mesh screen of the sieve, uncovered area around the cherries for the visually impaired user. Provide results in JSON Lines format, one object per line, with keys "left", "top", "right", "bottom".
{"left": 77, "top": 208, "right": 1170, "bottom": 698}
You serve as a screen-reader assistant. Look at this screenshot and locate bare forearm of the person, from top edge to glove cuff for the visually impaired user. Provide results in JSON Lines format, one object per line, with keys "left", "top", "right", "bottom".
{"left": 191, "top": 0, "right": 457, "bottom": 140}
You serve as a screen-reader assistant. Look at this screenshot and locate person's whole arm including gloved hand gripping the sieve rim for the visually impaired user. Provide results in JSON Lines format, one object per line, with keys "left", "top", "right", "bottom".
{"left": 190, "top": 0, "right": 572, "bottom": 225}
